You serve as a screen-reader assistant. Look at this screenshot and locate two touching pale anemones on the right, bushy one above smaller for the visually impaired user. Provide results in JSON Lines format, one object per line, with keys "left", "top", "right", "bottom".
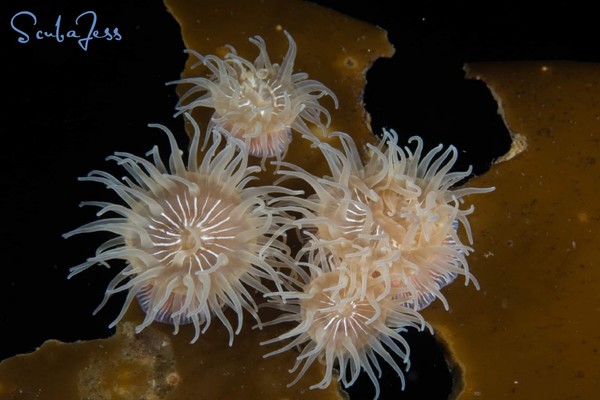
{"left": 262, "top": 131, "right": 492, "bottom": 396}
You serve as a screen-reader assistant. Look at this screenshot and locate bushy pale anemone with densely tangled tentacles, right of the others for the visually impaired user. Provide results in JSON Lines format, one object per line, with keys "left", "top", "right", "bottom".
{"left": 278, "top": 130, "right": 493, "bottom": 310}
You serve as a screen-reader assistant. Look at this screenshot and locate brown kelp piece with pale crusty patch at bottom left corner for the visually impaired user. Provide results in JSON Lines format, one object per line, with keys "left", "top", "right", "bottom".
{"left": 0, "top": 306, "right": 343, "bottom": 400}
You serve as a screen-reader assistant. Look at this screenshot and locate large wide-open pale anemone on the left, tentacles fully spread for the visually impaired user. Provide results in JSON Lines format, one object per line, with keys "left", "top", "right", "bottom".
{"left": 64, "top": 114, "right": 294, "bottom": 345}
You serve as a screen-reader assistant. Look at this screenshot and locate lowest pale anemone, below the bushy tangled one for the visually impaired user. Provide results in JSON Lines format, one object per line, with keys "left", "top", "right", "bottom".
{"left": 262, "top": 247, "right": 431, "bottom": 398}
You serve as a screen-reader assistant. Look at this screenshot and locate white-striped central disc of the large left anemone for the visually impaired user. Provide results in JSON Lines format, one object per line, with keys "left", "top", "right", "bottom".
{"left": 127, "top": 177, "right": 251, "bottom": 278}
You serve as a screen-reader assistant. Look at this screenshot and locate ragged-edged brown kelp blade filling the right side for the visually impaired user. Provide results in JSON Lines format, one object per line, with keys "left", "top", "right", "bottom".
{"left": 424, "top": 62, "right": 600, "bottom": 400}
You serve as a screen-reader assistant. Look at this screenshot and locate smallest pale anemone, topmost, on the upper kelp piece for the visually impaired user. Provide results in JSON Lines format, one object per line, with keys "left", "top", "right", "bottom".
{"left": 170, "top": 32, "right": 338, "bottom": 165}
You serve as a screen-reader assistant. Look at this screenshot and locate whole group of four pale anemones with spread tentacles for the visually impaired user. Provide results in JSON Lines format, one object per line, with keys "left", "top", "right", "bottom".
{"left": 65, "top": 32, "right": 492, "bottom": 397}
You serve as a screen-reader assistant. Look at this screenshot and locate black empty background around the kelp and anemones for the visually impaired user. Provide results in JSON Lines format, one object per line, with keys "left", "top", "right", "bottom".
{"left": 0, "top": 0, "right": 600, "bottom": 400}
